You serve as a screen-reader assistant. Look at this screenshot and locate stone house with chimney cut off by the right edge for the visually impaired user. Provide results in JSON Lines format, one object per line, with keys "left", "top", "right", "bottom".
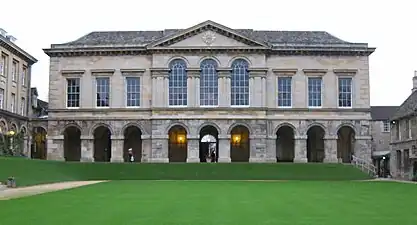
{"left": 391, "top": 71, "right": 417, "bottom": 179}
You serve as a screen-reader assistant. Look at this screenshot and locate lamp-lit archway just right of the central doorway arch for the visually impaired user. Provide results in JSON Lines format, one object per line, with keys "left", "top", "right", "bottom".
{"left": 230, "top": 125, "right": 250, "bottom": 162}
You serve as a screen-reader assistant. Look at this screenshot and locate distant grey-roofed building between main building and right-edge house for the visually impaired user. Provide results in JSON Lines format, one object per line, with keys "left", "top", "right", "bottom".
{"left": 371, "top": 106, "right": 398, "bottom": 177}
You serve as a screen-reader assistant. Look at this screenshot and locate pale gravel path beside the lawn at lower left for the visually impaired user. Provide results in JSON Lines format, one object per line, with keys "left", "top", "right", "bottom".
{"left": 0, "top": 181, "right": 106, "bottom": 201}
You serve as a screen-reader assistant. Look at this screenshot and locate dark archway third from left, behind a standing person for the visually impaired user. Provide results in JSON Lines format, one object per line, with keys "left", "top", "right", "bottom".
{"left": 123, "top": 125, "right": 142, "bottom": 162}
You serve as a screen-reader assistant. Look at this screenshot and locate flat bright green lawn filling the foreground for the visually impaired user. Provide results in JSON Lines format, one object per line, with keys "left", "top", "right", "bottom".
{"left": 0, "top": 181, "right": 417, "bottom": 225}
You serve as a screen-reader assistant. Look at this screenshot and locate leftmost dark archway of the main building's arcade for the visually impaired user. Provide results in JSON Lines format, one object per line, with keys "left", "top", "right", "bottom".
{"left": 64, "top": 126, "right": 81, "bottom": 161}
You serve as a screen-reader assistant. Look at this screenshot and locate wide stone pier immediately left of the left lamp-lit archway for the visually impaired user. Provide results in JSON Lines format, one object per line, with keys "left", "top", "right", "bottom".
{"left": 148, "top": 134, "right": 169, "bottom": 163}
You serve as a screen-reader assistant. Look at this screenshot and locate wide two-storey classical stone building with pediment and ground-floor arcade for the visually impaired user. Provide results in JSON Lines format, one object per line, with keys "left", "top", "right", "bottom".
{"left": 44, "top": 21, "right": 375, "bottom": 163}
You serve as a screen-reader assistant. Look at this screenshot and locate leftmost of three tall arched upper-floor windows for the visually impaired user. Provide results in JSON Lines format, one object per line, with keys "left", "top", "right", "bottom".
{"left": 168, "top": 59, "right": 187, "bottom": 106}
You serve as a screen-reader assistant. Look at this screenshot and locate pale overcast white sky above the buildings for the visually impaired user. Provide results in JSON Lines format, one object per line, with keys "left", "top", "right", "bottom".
{"left": 0, "top": 0, "right": 417, "bottom": 105}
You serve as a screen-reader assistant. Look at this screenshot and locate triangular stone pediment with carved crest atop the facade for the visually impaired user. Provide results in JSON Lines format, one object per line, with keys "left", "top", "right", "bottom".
{"left": 148, "top": 21, "right": 268, "bottom": 48}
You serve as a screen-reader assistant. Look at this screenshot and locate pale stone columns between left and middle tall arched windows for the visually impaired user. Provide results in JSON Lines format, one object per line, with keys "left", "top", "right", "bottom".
{"left": 187, "top": 68, "right": 200, "bottom": 107}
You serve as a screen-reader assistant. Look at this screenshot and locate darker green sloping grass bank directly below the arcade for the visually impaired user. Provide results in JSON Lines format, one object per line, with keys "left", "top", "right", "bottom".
{"left": 0, "top": 157, "right": 370, "bottom": 186}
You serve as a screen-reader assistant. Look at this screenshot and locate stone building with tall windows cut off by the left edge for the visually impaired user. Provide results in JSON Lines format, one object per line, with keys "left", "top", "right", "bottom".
{"left": 0, "top": 28, "right": 37, "bottom": 154}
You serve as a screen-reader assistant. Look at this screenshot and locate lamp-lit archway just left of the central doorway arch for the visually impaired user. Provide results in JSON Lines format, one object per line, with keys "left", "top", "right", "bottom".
{"left": 168, "top": 125, "right": 188, "bottom": 162}
